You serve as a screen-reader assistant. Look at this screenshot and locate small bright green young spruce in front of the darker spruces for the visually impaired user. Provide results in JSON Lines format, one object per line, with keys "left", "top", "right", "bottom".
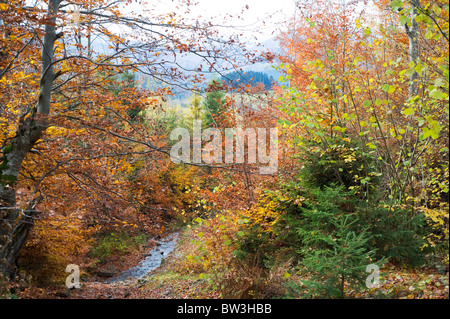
{"left": 295, "top": 187, "right": 379, "bottom": 298}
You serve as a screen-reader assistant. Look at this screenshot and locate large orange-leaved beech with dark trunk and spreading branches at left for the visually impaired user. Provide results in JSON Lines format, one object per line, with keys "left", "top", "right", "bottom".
{"left": 0, "top": 0, "right": 256, "bottom": 274}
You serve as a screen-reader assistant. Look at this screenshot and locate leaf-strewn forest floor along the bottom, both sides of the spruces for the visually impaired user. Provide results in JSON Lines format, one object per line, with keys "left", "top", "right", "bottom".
{"left": 17, "top": 229, "right": 449, "bottom": 299}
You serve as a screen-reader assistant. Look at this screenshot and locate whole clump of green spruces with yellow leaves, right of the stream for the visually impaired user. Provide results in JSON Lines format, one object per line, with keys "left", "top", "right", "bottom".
{"left": 256, "top": 134, "right": 428, "bottom": 298}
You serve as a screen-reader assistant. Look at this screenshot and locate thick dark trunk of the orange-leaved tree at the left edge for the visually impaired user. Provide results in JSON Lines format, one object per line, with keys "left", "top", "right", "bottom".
{"left": 0, "top": 0, "right": 61, "bottom": 276}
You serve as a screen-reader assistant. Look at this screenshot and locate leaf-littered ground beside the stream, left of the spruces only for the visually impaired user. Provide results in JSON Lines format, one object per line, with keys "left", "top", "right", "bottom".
{"left": 17, "top": 231, "right": 220, "bottom": 299}
